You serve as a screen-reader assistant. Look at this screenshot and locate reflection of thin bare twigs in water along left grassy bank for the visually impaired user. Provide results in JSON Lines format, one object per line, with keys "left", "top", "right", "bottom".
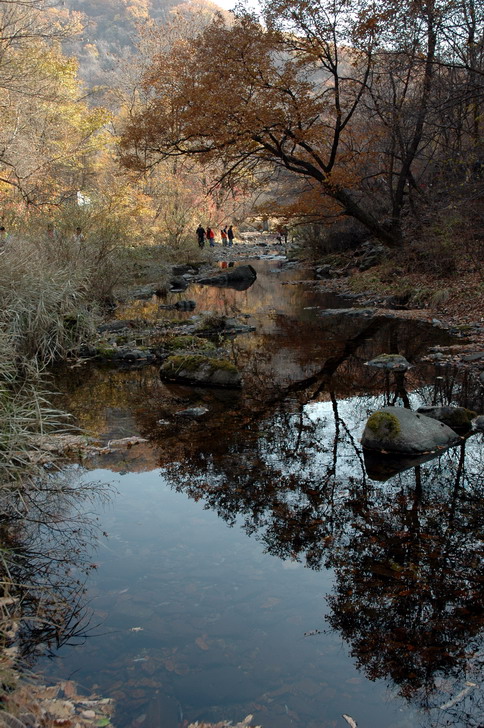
{"left": 0, "top": 472, "right": 106, "bottom": 659}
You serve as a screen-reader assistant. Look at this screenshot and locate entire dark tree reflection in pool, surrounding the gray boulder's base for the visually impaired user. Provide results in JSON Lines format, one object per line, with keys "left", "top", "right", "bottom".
{"left": 165, "top": 388, "right": 484, "bottom": 725}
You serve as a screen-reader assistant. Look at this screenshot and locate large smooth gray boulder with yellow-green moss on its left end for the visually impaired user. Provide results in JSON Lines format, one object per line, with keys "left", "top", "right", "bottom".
{"left": 361, "top": 407, "right": 460, "bottom": 454}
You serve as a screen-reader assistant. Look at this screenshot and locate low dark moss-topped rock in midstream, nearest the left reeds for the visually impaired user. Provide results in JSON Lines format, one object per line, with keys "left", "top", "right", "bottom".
{"left": 160, "top": 354, "right": 242, "bottom": 387}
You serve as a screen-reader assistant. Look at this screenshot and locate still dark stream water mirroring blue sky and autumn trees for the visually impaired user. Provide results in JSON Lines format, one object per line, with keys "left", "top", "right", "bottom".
{"left": 37, "top": 261, "right": 484, "bottom": 728}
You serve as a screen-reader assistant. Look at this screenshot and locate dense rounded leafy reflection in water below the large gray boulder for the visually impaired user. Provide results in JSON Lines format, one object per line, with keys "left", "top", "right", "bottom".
{"left": 330, "top": 449, "right": 484, "bottom": 725}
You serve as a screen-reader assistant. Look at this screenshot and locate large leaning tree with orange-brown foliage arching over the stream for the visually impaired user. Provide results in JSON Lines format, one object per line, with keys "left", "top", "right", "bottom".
{"left": 119, "top": 0, "right": 483, "bottom": 245}
